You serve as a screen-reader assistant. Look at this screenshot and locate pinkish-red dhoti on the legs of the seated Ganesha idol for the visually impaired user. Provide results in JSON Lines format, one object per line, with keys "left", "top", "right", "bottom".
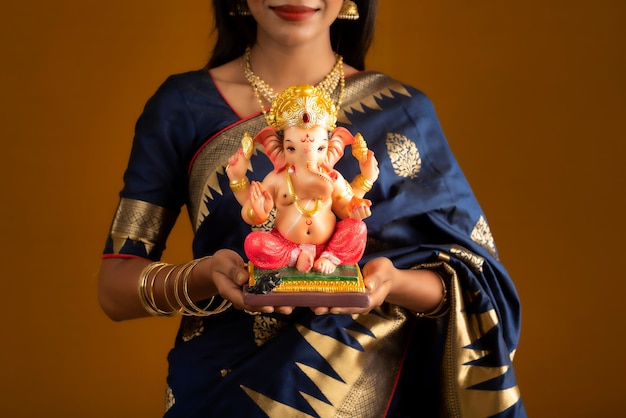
{"left": 244, "top": 219, "right": 367, "bottom": 269}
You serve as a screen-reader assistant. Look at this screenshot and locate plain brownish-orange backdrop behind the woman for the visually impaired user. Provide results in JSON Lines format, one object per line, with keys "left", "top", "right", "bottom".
{"left": 0, "top": 0, "right": 626, "bottom": 417}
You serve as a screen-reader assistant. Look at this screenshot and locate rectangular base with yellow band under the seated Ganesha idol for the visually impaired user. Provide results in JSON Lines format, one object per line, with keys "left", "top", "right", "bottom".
{"left": 243, "top": 263, "right": 369, "bottom": 308}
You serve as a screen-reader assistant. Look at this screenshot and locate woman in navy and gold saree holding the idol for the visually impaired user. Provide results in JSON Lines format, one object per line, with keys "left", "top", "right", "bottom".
{"left": 99, "top": 0, "right": 525, "bottom": 417}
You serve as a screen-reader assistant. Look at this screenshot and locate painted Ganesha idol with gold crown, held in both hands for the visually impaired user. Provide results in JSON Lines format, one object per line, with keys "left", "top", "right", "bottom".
{"left": 226, "top": 85, "right": 378, "bottom": 307}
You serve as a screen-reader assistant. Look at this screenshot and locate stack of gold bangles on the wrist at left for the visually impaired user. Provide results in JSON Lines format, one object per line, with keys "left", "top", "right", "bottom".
{"left": 138, "top": 257, "right": 232, "bottom": 316}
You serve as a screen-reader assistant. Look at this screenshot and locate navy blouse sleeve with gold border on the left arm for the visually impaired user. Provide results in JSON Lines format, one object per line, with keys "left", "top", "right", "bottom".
{"left": 104, "top": 78, "right": 196, "bottom": 260}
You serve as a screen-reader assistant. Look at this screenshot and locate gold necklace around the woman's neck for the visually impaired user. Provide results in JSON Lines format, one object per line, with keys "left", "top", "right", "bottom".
{"left": 243, "top": 47, "right": 346, "bottom": 119}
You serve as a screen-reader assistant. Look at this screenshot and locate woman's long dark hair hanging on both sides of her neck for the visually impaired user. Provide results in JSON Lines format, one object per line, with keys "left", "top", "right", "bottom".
{"left": 206, "top": 0, "right": 378, "bottom": 70}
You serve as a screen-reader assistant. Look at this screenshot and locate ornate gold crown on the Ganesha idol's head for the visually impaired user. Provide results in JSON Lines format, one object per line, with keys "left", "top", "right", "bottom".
{"left": 267, "top": 84, "right": 337, "bottom": 131}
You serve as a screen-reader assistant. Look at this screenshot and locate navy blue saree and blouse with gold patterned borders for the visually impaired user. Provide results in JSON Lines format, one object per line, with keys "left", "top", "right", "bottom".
{"left": 104, "top": 71, "right": 526, "bottom": 417}
